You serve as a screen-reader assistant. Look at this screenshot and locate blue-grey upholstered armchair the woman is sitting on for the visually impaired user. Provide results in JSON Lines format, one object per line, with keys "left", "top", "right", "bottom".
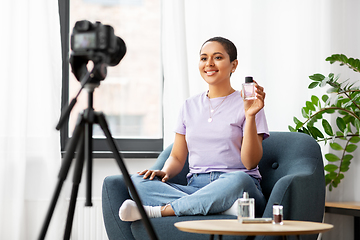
{"left": 102, "top": 132, "right": 325, "bottom": 240}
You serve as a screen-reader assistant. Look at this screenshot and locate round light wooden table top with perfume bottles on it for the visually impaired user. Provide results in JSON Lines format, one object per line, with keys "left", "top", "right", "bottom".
{"left": 175, "top": 219, "right": 333, "bottom": 239}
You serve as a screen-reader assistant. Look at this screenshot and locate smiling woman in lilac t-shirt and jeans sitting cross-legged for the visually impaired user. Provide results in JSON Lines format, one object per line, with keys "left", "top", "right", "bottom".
{"left": 119, "top": 37, "right": 269, "bottom": 221}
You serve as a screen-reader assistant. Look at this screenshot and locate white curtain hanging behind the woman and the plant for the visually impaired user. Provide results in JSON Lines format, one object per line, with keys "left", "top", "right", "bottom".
{"left": 162, "top": 0, "right": 360, "bottom": 239}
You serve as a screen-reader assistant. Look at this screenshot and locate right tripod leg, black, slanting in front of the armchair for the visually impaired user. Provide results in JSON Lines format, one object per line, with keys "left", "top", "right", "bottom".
{"left": 96, "top": 113, "right": 158, "bottom": 240}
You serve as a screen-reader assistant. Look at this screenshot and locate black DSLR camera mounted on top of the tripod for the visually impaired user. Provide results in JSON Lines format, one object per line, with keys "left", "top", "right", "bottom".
{"left": 70, "top": 20, "right": 126, "bottom": 81}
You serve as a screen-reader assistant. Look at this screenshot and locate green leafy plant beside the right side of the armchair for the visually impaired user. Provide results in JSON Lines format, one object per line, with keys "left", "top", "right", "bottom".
{"left": 289, "top": 54, "right": 360, "bottom": 191}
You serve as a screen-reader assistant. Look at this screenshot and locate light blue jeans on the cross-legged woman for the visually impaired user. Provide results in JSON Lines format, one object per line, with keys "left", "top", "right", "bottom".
{"left": 132, "top": 171, "right": 266, "bottom": 216}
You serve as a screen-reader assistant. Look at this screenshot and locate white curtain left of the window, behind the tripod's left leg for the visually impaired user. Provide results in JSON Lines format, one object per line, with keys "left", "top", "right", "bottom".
{"left": 0, "top": 0, "right": 63, "bottom": 240}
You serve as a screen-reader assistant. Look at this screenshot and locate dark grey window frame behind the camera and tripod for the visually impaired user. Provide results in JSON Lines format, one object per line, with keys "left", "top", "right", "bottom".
{"left": 58, "top": 0, "right": 164, "bottom": 158}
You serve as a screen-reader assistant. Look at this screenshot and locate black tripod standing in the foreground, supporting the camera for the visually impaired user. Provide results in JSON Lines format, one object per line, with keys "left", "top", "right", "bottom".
{"left": 38, "top": 70, "right": 157, "bottom": 240}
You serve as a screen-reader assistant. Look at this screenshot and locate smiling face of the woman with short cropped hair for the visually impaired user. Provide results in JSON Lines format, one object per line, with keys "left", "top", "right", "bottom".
{"left": 199, "top": 42, "right": 237, "bottom": 85}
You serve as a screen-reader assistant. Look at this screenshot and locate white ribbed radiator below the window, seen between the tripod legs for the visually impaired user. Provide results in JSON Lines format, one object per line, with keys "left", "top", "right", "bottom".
{"left": 69, "top": 199, "right": 109, "bottom": 240}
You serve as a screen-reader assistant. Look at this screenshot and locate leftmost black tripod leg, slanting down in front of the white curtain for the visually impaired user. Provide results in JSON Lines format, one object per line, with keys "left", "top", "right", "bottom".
{"left": 38, "top": 116, "right": 84, "bottom": 240}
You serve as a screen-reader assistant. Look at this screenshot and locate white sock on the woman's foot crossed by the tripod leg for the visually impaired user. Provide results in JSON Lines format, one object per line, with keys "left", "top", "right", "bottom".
{"left": 119, "top": 199, "right": 161, "bottom": 222}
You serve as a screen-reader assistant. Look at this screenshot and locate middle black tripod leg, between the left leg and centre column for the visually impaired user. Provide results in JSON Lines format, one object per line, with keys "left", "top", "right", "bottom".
{"left": 64, "top": 131, "right": 84, "bottom": 240}
